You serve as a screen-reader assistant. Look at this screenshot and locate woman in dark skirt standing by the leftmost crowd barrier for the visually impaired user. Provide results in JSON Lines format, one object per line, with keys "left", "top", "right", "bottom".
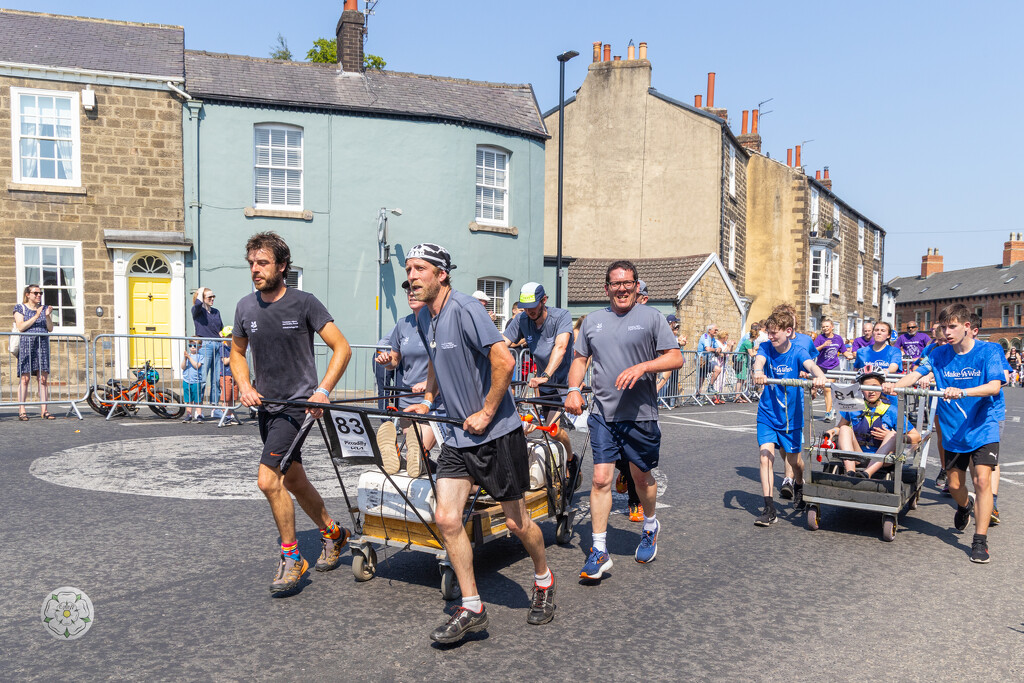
{"left": 14, "top": 285, "right": 53, "bottom": 422}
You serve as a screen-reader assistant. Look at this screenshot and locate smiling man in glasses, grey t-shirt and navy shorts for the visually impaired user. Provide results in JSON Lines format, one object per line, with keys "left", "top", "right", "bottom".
{"left": 565, "top": 261, "right": 683, "bottom": 580}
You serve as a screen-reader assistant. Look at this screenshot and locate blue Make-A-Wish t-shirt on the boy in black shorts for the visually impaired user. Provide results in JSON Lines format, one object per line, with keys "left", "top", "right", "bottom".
{"left": 918, "top": 342, "right": 1006, "bottom": 453}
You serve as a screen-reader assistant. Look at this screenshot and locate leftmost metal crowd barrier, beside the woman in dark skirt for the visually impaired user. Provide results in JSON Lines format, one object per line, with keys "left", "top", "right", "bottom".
{"left": 0, "top": 332, "right": 90, "bottom": 420}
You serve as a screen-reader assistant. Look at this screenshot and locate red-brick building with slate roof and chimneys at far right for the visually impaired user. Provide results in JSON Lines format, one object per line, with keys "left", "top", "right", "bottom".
{"left": 888, "top": 237, "right": 1024, "bottom": 349}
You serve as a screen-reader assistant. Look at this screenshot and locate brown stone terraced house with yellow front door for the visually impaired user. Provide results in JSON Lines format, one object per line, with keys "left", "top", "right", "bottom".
{"left": 0, "top": 9, "right": 189, "bottom": 366}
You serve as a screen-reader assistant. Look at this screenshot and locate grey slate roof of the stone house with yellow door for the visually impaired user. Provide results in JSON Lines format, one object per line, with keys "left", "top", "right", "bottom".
{"left": 0, "top": 9, "right": 185, "bottom": 80}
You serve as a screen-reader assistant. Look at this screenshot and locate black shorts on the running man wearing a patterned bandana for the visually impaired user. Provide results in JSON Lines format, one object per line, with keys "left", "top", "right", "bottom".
{"left": 437, "top": 427, "right": 529, "bottom": 502}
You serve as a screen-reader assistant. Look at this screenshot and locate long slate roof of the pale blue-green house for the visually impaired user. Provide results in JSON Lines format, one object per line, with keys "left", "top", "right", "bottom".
{"left": 185, "top": 50, "right": 549, "bottom": 139}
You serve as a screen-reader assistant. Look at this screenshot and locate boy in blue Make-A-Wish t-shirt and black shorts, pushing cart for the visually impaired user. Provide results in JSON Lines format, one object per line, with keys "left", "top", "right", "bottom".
{"left": 883, "top": 304, "right": 1006, "bottom": 563}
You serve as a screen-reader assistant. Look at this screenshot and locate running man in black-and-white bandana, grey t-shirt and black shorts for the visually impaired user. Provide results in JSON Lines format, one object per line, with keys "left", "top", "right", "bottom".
{"left": 406, "top": 243, "right": 555, "bottom": 643}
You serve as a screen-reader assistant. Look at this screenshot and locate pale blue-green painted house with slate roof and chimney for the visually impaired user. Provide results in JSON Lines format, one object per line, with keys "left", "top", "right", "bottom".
{"left": 184, "top": 2, "right": 548, "bottom": 344}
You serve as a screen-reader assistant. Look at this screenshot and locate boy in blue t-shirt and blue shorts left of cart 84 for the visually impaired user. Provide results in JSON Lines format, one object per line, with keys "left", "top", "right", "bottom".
{"left": 754, "top": 309, "right": 825, "bottom": 526}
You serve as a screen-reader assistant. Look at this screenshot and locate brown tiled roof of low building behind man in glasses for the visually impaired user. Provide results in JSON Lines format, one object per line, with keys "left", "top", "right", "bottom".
{"left": 567, "top": 254, "right": 711, "bottom": 303}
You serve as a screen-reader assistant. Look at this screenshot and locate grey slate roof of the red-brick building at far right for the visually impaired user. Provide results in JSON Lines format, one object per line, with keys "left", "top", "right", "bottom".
{"left": 889, "top": 261, "right": 1024, "bottom": 305}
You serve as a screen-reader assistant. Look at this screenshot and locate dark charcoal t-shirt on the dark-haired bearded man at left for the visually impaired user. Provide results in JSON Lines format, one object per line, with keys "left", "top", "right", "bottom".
{"left": 231, "top": 287, "right": 334, "bottom": 413}
